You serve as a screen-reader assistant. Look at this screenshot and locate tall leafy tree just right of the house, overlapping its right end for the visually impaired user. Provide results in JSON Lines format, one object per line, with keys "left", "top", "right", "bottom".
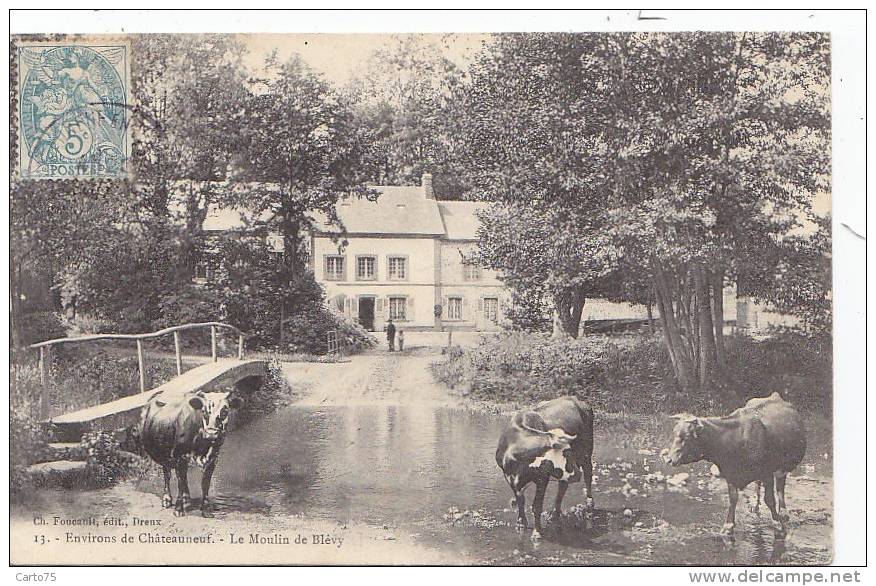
{"left": 459, "top": 34, "right": 617, "bottom": 336}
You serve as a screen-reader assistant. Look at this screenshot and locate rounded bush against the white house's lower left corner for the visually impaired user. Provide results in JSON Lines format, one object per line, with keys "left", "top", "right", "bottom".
{"left": 281, "top": 303, "right": 377, "bottom": 354}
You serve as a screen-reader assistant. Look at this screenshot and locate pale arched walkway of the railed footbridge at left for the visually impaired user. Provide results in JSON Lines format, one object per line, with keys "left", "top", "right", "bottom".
{"left": 51, "top": 359, "right": 268, "bottom": 434}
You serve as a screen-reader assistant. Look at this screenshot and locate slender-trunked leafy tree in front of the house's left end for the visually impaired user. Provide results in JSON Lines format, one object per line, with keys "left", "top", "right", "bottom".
{"left": 231, "top": 55, "right": 374, "bottom": 341}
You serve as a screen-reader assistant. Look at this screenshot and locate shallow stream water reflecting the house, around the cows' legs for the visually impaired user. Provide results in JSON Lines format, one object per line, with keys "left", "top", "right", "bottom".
{"left": 204, "top": 404, "right": 825, "bottom": 565}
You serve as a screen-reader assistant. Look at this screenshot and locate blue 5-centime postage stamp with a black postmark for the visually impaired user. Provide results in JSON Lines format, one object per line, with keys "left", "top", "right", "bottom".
{"left": 17, "top": 39, "right": 131, "bottom": 179}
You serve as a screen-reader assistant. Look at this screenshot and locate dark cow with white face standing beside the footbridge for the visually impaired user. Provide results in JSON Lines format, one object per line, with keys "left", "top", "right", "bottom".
{"left": 137, "top": 392, "right": 243, "bottom": 517}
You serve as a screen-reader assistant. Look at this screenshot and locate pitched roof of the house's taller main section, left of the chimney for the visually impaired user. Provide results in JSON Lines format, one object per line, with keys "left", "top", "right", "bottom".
{"left": 314, "top": 185, "right": 444, "bottom": 236}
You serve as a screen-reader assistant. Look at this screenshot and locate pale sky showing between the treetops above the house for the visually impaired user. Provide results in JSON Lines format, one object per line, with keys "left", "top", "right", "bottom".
{"left": 239, "top": 33, "right": 489, "bottom": 86}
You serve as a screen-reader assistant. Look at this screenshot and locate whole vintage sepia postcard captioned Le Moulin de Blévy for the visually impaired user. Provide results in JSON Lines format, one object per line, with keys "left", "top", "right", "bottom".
{"left": 9, "top": 9, "right": 863, "bottom": 566}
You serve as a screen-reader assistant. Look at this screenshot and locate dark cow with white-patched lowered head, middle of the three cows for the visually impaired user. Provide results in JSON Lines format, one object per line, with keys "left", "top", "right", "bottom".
{"left": 496, "top": 397, "right": 593, "bottom": 539}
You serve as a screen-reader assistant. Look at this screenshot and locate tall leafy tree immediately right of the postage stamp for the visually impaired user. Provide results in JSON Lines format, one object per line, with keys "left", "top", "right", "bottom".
{"left": 134, "top": 35, "right": 247, "bottom": 280}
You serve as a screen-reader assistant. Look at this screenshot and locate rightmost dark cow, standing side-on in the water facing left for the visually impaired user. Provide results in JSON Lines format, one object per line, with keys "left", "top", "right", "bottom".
{"left": 663, "top": 393, "right": 806, "bottom": 535}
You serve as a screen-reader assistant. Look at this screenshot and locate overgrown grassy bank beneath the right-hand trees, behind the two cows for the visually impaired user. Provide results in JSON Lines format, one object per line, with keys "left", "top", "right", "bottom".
{"left": 433, "top": 332, "right": 832, "bottom": 415}
